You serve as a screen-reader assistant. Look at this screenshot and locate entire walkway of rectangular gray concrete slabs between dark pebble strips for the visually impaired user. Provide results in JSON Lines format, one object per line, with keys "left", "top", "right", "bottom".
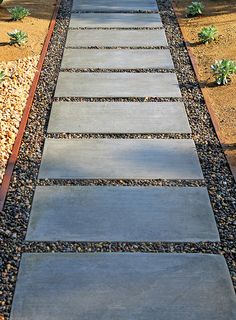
{"left": 11, "top": 0, "right": 236, "bottom": 320}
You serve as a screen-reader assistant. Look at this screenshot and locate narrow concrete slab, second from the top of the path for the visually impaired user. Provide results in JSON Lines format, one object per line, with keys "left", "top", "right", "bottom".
{"left": 70, "top": 13, "right": 162, "bottom": 28}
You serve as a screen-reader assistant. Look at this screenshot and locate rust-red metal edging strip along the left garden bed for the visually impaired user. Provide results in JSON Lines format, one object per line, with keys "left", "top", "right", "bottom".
{"left": 0, "top": 0, "right": 61, "bottom": 211}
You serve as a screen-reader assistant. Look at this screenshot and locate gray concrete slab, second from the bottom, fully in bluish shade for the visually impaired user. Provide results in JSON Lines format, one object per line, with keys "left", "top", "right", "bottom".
{"left": 26, "top": 186, "right": 220, "bottom": 242}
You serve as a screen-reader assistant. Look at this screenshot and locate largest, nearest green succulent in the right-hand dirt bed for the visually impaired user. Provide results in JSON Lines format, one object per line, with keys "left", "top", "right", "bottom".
{"left": 211, "top": 60, "right": 236, "bottom": 85}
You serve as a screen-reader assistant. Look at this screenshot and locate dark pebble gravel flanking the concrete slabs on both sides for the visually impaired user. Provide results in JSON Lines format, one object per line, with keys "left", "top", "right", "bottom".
{"left": 0, "top": 0, "right": 236, "bottom": 319}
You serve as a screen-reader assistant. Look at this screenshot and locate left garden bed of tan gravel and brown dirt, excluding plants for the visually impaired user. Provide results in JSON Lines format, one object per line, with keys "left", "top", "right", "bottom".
{"left": 0, "top": 0, "right": 57, "bottom": 184}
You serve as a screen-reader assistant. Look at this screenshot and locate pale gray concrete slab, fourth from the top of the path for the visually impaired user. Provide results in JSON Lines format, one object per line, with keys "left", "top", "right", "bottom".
{"left": 61, "top": 49, "right": 174, "bottom": 69}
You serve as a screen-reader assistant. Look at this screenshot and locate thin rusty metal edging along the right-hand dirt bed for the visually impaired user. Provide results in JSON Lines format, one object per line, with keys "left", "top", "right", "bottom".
{"left": 172, "top": 1, "right": 236, "bottom": 180}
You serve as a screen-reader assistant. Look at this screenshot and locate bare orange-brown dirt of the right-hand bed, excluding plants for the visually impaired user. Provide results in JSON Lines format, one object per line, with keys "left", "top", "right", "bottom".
{"left": 175, "top": 0, "right": 236, "bottom": 177}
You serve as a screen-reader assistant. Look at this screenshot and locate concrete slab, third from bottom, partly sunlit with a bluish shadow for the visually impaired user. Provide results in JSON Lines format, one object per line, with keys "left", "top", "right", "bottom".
{"left": 39, "top": 139, "right": 203, "bottom": 179}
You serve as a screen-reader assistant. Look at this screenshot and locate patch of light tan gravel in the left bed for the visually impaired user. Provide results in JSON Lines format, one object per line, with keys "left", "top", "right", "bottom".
{"left": 0, "top": 56, "right": 39, "bottom": 184}
